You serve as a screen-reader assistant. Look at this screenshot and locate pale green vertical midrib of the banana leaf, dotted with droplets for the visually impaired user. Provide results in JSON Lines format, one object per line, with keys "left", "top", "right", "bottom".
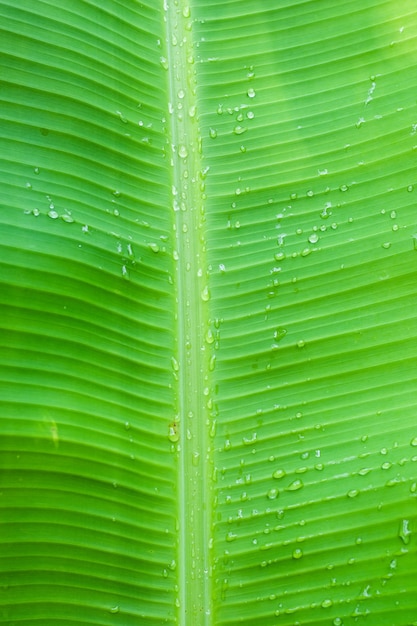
{"left": 163, "top": 0, "right": 212, "bottom": 626}
